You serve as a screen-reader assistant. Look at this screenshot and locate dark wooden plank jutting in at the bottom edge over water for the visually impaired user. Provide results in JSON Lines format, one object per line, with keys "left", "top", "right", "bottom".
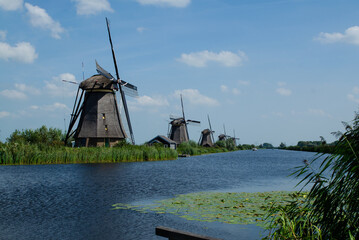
{"left": 156, "top": 226, "right": 221, "bottom": 240}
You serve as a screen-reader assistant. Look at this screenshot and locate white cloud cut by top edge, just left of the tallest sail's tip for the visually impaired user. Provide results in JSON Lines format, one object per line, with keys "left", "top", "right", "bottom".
{"left": 72, "top": 0, "right": 113, "bottom": 15}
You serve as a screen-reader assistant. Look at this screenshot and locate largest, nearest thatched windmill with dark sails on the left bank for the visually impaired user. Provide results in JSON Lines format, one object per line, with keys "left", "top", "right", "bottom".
{"left": 65, "top": 18, "right": 138, "bottom": 147}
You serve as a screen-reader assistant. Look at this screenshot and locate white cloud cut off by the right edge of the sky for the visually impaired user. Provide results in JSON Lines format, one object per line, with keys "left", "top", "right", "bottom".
{"left": 314, "top": 26, "right": 359, "bottom": 45}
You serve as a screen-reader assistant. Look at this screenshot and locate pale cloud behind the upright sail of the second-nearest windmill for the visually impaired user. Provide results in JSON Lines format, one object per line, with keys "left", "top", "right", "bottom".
{"left": 174, "top": 89, "right": 219, "bottom": 107}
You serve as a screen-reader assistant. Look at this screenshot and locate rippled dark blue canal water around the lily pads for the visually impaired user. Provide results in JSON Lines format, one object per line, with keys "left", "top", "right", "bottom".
{"left": 0, "top": 150, "right": 320, "bottom": 240}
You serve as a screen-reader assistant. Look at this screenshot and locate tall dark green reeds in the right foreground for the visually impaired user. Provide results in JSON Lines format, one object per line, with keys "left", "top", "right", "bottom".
{"left": 269, "top": 113, "right": 359, "bottom": 239}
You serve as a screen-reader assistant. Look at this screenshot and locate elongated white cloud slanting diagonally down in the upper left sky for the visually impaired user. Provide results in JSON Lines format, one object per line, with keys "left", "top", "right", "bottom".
{"left": 25, "top": 3, "right": 65, "bottom": 39}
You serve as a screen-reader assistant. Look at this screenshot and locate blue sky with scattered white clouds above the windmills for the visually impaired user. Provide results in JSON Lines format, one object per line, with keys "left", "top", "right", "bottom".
{"left": 0, "top": 0, "right": 359, "bottom": 146}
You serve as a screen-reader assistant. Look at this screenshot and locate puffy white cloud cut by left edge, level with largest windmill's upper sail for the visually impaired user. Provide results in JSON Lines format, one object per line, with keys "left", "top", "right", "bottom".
{"left": 0, "top": 42, "right": 38, "bottom": 63}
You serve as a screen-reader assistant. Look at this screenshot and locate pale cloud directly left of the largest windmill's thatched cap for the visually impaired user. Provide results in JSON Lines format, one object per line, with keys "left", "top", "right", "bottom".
{"left": 44, "top": 73, "right": 78, "bottom": 97}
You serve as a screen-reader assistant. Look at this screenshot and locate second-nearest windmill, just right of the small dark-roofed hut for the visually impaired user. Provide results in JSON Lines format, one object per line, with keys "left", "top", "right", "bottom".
{"left": 168, "top": 94, "right": 201, "bottom": 144}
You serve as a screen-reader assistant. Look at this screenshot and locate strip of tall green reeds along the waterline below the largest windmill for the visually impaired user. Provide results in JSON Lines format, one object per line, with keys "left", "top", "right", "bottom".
{"left": 0, "top": 143, "right": 177, "bottom": 165}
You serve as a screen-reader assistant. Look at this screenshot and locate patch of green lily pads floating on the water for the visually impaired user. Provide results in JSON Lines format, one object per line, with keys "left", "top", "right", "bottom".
{"left": 112, "top": 191, "right": 305, "bottom": 226}
